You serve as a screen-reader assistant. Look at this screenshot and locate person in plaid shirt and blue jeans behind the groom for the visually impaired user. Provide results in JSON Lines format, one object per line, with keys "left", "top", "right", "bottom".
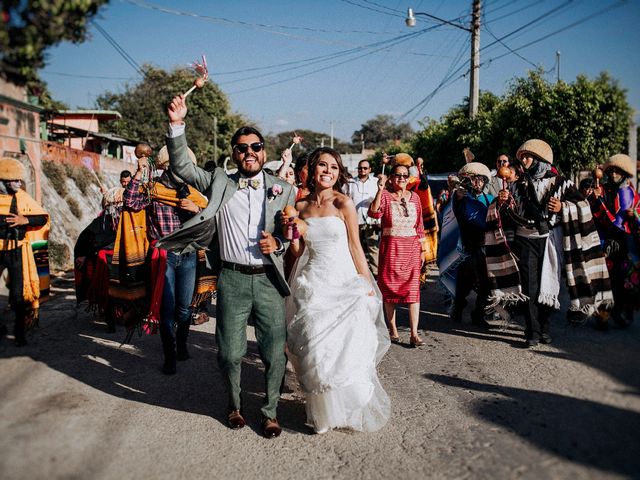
{"left": 123, "top": 146, "right": 207, "bottom": 375}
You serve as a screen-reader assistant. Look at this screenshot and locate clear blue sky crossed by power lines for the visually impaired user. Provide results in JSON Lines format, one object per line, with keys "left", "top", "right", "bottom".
{"left": 41, "top": 0, "right": 640, "bottom": 140}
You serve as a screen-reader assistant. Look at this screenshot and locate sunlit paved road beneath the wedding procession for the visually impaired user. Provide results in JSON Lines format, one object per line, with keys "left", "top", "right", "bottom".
{"left": 0, "top": 270, "right": 640, "bottom": 480}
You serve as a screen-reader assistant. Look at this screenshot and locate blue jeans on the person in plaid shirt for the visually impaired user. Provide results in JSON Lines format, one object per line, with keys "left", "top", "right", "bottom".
{"left": 160, "top": 252, "right": 198, "bottom": 337}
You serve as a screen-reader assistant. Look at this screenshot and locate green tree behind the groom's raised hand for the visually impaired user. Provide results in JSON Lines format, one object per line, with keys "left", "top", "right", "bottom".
{"left": 96, "top": 64, "right": 247, "bottom": 164}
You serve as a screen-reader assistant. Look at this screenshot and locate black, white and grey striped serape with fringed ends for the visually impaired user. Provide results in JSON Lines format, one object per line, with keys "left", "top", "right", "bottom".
{"left": 485, "top": 175, "right": 613, "bottom": 314}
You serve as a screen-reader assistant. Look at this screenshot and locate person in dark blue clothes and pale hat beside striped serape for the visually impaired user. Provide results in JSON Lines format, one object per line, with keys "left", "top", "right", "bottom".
{"left": 452, "top": 162, "right": 494, "bottom": 328}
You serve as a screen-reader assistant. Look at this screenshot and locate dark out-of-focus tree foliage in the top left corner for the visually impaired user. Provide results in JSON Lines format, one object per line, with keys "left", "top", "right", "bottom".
{"left": 0, "top": 0, "right": 108, "bottom": 85}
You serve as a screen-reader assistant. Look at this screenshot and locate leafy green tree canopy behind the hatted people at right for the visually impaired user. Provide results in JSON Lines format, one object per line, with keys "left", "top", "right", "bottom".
{"left": 413, "top": 71, "right": 631, "bottom": 174}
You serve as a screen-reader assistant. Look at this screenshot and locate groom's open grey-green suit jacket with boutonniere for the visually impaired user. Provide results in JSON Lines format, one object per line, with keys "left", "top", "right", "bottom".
{"left": 158, "top": 134, "right": 295, "bottom": 296}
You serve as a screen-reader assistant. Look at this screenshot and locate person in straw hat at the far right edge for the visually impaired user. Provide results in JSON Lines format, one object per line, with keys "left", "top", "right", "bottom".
{"left": 589, "top": 153, "right": 640, "bottom": 330}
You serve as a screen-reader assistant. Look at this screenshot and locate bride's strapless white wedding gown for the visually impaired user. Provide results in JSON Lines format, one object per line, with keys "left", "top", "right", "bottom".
{"left": 287, "top": 216, "right": 391, "bottom": 432}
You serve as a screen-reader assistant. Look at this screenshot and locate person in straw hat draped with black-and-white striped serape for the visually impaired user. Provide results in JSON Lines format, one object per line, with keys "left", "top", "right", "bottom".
{"left": 492, "top": 139, "right": 612, "bottom": 347}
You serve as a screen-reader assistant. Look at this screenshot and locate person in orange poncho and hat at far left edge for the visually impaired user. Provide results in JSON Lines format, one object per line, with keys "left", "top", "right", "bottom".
{"left": 0, "top": 157, "right": 49, "bottom": 346}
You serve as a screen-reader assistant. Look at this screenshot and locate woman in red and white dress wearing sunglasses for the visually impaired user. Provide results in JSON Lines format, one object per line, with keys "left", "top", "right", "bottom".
{"left": 369, "top": 159, "right": 426, "bottom": 347}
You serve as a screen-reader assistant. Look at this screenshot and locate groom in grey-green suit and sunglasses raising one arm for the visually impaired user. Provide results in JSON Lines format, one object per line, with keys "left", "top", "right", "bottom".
{"left": 159, "top": 95, "right": 295, "bottom": 438}
